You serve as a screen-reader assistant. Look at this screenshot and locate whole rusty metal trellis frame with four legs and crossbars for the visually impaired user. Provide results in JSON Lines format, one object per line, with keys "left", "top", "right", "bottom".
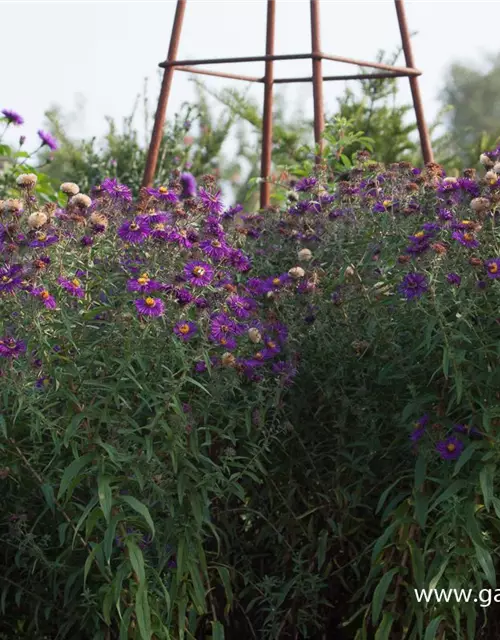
{"left": 142, "top": 0, "right": 433, "bottom": 209}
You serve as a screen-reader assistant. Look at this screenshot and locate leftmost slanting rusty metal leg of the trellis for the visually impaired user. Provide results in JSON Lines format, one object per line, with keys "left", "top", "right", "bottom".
{"left": 142, "top": 0, "right": 186, "bottom": 187}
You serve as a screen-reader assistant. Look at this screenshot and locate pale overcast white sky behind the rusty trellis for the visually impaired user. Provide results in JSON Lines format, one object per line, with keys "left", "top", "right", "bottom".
{"left": 0, "top": 0, "right": 500, "bottom": 151}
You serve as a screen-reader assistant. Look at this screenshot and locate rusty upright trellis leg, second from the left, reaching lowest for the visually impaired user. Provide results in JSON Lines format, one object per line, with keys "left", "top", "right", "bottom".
{"left": 260, "top": 0, "right": 276, "bottom": 209}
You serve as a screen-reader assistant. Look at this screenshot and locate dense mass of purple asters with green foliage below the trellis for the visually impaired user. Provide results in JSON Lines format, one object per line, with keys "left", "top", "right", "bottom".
{"left": 0, "top": 100, "right": 500, "bottom": 640}
